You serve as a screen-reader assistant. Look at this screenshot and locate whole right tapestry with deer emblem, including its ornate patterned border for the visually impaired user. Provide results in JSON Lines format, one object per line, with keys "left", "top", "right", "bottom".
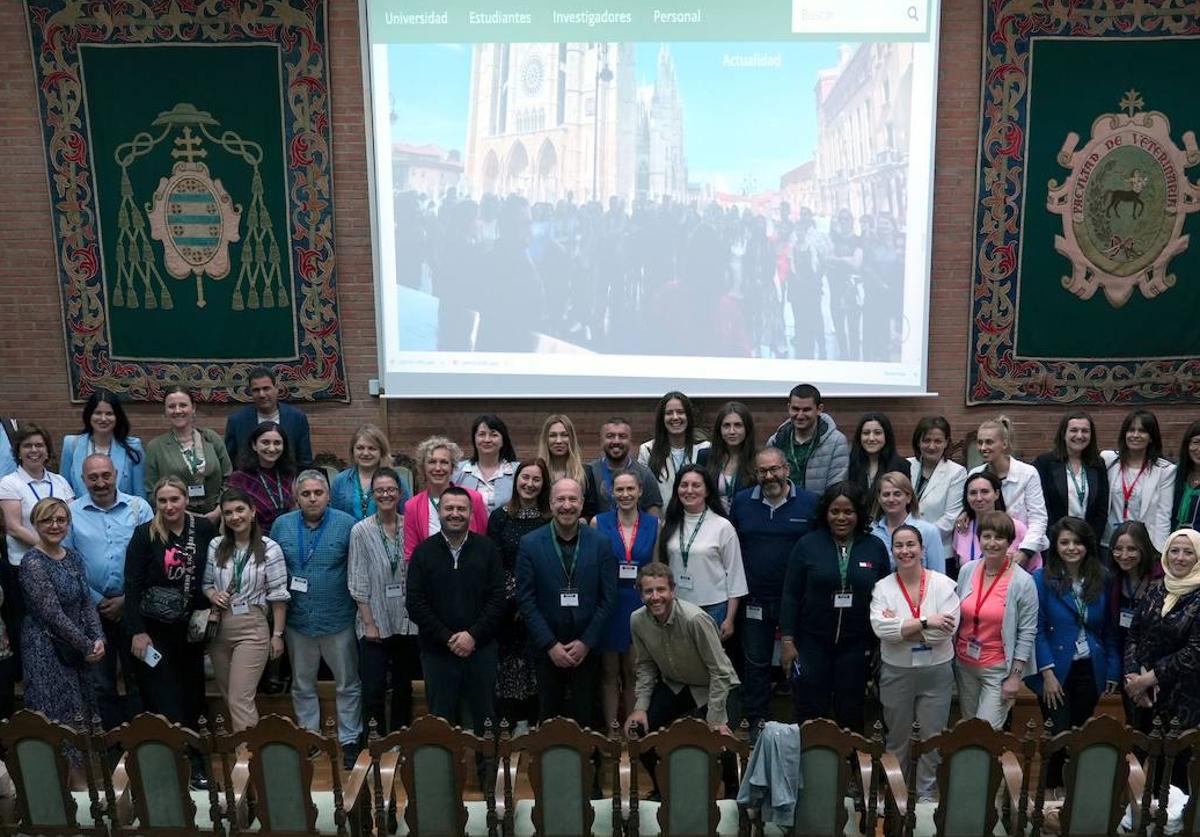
{"left": 966, "top": 0, "right": 1200, "bottom": 404}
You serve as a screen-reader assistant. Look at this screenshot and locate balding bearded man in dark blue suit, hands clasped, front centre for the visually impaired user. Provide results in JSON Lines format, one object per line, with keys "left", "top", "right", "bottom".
{"left": 517, "top": 477, "right": 617, "bottom": 727}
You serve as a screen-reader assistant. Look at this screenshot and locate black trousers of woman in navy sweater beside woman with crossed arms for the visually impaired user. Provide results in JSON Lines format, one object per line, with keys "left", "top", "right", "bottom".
{"left": 792, "top": 637, "right": 871, "bottom": 733}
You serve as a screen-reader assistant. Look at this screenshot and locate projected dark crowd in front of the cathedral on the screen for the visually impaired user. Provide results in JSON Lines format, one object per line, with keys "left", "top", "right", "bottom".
{"left": 395, "top": 189, "right": 905, "bottom": 361}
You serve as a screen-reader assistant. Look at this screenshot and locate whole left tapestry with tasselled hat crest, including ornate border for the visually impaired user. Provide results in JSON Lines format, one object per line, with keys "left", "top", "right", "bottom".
{"left": 25, "top": 0, "right": 347, "bottom": 402}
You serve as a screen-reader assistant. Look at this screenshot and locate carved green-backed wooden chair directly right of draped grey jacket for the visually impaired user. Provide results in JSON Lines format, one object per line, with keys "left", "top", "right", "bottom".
{"left": 782, "top": 718, "right": 883, "bottom": 837}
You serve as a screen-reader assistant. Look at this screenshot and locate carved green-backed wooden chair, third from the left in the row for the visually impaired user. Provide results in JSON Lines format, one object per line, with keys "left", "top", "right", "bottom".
{"left": 212, "top": 715, "right": 371, "bottom": 835}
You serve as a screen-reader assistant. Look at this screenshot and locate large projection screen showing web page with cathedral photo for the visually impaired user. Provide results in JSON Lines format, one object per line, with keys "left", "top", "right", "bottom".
{"left": 365, "top": 0, "right": 940, "bottom": 398}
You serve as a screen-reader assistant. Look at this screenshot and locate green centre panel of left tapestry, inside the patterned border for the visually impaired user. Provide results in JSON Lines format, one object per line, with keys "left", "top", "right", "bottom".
{"left": 79, "top": 44, "right": 296, "bottom": 360}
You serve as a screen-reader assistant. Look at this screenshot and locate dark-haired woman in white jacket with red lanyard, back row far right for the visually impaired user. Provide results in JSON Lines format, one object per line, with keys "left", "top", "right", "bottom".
{"left": 1100, "top": 410, "right": 1175, "bottom": 552}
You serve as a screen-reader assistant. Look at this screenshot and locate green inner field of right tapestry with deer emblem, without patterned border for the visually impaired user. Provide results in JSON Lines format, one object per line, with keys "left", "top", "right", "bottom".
{"left": 1016, "top": 38, "right": 1200, "bottom": 360}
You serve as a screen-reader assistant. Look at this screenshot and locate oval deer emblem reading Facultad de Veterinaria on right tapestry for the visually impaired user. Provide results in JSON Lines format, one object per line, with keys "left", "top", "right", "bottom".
{"left": 1046, "top": 90, "right": 1200, "bottom": 308}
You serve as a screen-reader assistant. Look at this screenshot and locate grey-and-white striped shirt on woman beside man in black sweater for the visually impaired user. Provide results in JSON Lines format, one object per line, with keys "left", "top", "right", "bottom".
{"left": 347, "top": 514, "right": 416, "bottom": 638}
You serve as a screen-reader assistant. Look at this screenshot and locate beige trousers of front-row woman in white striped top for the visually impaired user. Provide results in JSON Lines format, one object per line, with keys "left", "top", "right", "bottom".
{"left": 209, "top": 606, "right": 271, "bottom": 731}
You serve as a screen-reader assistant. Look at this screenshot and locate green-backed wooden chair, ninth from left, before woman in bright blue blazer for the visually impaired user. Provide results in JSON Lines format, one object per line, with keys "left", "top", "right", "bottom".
{"left": 1032, "top": 715, "right": 1153, "bottom": 837}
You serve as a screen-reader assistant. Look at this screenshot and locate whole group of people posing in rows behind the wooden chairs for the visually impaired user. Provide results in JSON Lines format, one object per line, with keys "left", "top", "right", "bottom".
{"left": 0, "top": 368, "right": 1200, "bottom": 796}
